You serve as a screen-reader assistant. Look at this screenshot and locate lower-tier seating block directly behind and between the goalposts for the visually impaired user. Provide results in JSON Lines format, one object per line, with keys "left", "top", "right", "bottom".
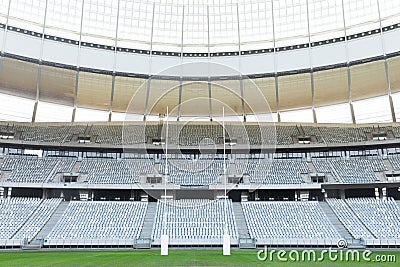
{"left": 152, "top": 199, "right": 238, "bottom": 240}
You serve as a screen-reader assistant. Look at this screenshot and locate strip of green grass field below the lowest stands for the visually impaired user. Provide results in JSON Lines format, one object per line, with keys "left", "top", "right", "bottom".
{"left": 0, "top": 250, "right": 400, "bottom": 267}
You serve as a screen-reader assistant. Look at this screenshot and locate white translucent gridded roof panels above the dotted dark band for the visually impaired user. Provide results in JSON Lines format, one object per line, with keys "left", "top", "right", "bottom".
{"left": 0, "top": 0, "right": 400, "bottom": 52}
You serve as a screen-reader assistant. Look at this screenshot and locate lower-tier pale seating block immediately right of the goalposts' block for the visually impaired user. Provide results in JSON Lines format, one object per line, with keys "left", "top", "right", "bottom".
{"left": 242, "top": 201, "right": 340, "bottom": 242}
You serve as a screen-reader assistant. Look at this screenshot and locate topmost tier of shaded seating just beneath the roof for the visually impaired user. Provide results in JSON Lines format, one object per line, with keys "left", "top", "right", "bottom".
{"left": 0, "top": 122, "right": 400, "bottom": 146}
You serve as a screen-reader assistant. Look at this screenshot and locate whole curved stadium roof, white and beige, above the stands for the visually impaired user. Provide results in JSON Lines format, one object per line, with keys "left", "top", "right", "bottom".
{"left": 0, "top": 0, "right": 400, "bottom": 123}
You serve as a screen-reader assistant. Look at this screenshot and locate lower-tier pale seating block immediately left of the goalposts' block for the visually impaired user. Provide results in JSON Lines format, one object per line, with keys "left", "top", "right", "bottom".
{"left": 47, "top": 201, "right": 147, "bottom": 240}
